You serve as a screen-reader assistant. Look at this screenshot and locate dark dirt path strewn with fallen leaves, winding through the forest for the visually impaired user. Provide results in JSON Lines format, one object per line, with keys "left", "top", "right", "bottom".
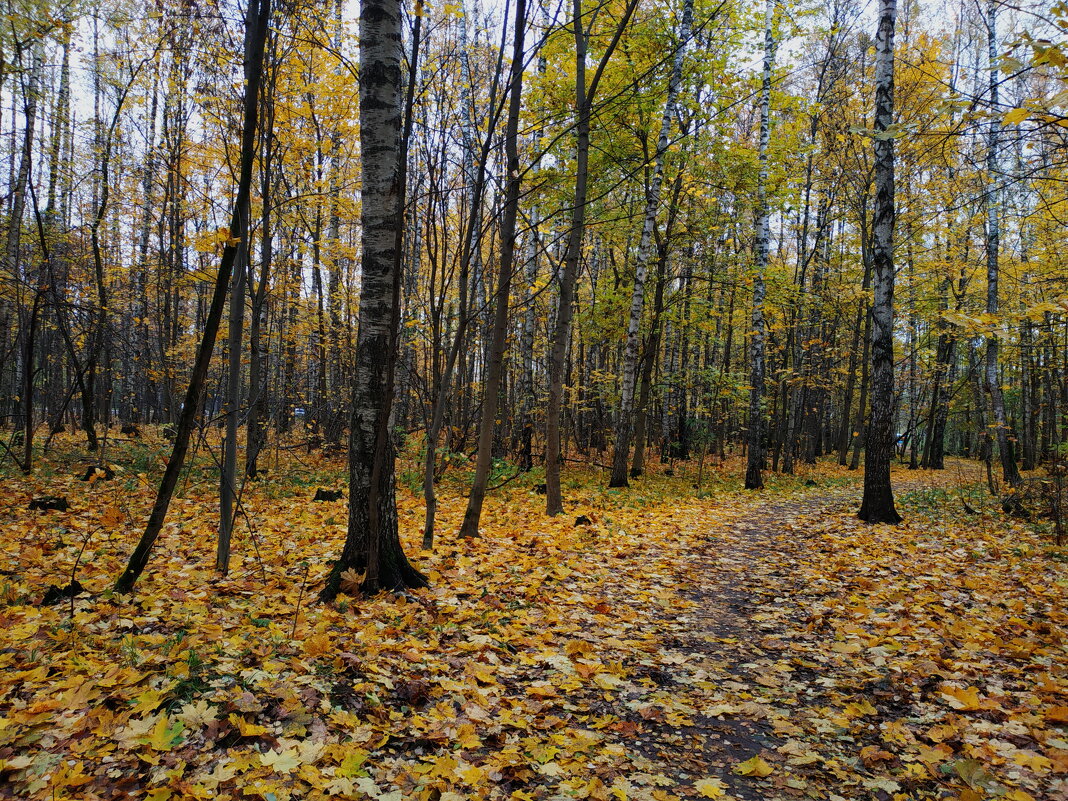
{"left": 593, "top": 488, "right": 855, "bottom": 801}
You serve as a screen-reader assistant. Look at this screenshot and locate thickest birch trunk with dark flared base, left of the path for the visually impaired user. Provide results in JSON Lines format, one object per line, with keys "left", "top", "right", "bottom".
{"left": 319, "top": 0, "right": 426, "bottom": 601}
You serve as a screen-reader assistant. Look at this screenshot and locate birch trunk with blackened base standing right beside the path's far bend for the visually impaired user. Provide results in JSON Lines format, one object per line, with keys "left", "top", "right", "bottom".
{"left": 858, "top": 0, "right": 901, "bottom": 523}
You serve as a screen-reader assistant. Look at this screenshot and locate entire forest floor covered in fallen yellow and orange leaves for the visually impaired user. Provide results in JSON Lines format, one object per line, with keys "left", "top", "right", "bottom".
{"left": 0, "top": 436, "right": 1068, "bottom": 801}
